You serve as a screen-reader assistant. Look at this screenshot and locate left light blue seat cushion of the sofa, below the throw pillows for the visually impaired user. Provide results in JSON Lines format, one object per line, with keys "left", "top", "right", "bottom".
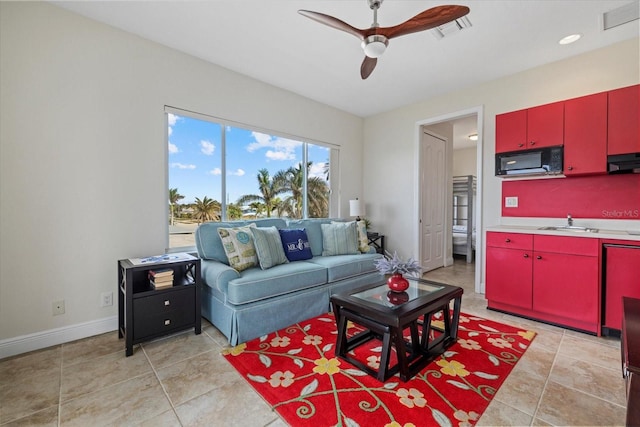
{"left": 227, "top": 261, "right": 327, "bottom": 305}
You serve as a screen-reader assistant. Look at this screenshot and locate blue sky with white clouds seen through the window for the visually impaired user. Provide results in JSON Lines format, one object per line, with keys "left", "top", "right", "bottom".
{"left": 167, "top": 113, "right": 329, "bottom": 204}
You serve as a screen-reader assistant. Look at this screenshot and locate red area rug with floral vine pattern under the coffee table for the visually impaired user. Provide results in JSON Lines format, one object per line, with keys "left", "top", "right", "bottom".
{"left": 223, "top": 313, "right": 535, "bottom": 427}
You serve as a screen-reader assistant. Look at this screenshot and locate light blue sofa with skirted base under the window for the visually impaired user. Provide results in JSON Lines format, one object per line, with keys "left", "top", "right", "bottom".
{"left": 195, "top": 218, "right": 384, "bottom": 345}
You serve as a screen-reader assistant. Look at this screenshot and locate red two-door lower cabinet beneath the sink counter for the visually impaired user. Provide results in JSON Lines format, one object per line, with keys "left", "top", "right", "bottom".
{"left": 486, "top": 232, "right": 600, "bottom": 334}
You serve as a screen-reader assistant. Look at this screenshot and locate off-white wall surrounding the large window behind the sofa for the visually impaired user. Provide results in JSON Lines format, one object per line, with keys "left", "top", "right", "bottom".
{"left": 0, "top": 2, "right": 363, "bottom": 357}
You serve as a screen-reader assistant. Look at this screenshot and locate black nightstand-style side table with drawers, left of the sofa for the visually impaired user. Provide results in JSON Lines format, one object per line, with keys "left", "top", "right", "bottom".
{"left": 118, "top": 254, "right": 202, "bottom": 356}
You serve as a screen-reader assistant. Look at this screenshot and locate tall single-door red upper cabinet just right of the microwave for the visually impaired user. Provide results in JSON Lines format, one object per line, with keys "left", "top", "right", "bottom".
{"left": 564, "top": 92, "right": 607, "bottom": 176}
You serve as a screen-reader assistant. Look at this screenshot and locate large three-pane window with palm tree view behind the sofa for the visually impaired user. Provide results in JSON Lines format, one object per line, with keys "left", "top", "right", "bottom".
{"left": 166, "top": 107, "right": 338, "bottom": 248}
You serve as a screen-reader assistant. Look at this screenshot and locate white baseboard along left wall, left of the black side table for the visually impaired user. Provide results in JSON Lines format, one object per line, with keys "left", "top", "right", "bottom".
{"left": 0, "top": 316, "right": 118, "bottom": 359}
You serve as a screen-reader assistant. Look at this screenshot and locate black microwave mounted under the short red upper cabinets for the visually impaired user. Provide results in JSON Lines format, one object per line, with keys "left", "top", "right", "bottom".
{"left": 496, "top": 147, "right": 563, "bottom": 177}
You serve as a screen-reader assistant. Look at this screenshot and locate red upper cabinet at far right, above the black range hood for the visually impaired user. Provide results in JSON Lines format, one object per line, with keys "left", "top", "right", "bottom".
{"left": 607, "top": 85, "right": 640, "bottom": 155}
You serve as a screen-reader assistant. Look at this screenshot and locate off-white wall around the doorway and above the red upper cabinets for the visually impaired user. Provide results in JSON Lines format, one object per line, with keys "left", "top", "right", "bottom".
{"left": 363, "top": 38, "right": 640, "bottom": 288}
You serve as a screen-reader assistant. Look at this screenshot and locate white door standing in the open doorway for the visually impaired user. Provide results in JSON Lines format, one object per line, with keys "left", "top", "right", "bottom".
{"left": 420, "top": 131, "right": 446, "bottom": 272}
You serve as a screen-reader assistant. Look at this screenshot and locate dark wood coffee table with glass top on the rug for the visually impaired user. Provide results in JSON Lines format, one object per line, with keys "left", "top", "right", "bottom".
{"left": 331, "top": 279, "right": 463, "bottom": 382}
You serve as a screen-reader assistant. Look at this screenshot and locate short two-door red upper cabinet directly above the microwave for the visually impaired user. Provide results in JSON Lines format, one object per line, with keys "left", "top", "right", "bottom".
{"left": 496, "top": 102, "right": 564, "bottom": 153}
